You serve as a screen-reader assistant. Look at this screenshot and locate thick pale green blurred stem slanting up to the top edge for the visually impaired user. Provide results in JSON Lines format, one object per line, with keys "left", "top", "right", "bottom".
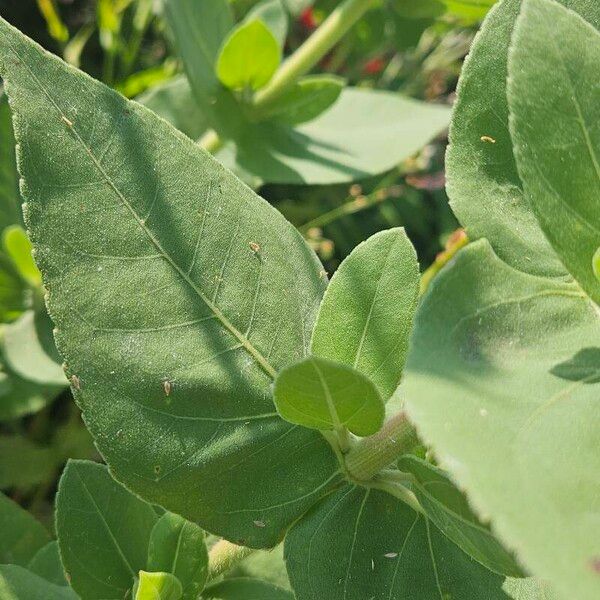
{"left": 254, "top": 0, "right": 373, "bottom": 106}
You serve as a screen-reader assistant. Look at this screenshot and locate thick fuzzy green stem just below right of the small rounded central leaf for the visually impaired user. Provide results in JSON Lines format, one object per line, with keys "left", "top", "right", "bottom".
{"left": 345, "top": 412, "right": 418, "bottom": 482}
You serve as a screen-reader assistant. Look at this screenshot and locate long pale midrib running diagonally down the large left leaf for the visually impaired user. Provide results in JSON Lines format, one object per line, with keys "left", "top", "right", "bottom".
{"left": 8, "top": 41, "right": 277, "bottom": 379}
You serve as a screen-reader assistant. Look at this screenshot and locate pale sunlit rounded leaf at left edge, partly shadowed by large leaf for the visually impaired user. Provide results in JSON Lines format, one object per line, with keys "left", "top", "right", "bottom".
{"left": 1, "top": 305, "right": 67, "bottom": 387}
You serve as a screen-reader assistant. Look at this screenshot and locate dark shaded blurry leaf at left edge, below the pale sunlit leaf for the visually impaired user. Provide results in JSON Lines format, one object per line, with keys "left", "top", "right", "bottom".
{"left": 0, "top": 434, "right": 59, "bottom": 489}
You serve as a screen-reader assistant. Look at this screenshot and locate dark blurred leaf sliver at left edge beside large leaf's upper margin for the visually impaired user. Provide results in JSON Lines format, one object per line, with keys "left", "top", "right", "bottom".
{"left": 0, "top": 88, "right": 21, "bottom": 231}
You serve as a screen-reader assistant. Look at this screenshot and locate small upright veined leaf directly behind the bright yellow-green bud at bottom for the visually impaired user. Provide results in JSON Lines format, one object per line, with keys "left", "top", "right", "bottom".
{"left": 146, "top": 512, "right": 208, "bottom": 600}
